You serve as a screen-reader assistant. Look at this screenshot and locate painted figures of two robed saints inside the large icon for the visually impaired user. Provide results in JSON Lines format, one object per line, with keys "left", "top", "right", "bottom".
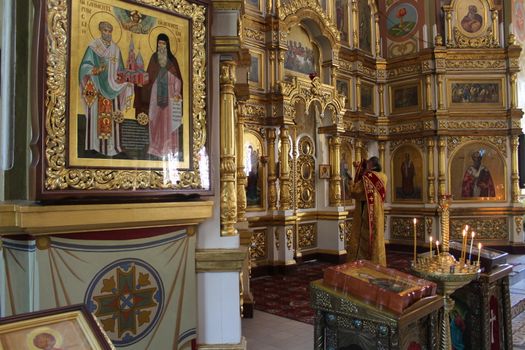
{"left": 79, "top": 10, "right": 183, "bottom": 159}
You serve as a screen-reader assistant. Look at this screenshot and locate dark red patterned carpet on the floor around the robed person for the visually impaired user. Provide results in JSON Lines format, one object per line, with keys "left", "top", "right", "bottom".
{"left": 250, "top": 253, "right": 411, "bottom": 324}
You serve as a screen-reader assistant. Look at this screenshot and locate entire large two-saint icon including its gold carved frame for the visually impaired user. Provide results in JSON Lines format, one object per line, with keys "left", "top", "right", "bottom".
{"left": 32, "top": 0, "right": 211, "bottom": 201}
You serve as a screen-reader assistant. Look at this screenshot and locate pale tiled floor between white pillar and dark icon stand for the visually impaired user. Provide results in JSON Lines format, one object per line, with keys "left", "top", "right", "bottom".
{"left": 242, "top": 310, "right": 314, "bottom": 350}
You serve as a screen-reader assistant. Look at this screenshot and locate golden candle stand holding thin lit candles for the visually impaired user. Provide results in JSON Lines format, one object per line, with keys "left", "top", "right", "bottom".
{"left": 412, "top": 195, "right": 480, "bottom": 350}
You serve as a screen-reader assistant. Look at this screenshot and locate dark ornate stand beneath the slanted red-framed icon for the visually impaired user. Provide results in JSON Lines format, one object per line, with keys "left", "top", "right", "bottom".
{"left": 310, "top": 280, "right": 443, "bottom": 350}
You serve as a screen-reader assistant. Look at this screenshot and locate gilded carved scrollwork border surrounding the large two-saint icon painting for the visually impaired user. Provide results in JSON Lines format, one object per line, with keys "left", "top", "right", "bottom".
{"left": 44, "top": 0, "right": 207, "bottom": 191}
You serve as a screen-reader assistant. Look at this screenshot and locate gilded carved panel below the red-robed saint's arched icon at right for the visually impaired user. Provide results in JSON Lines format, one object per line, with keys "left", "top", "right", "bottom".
{"left": 450, "top": 216, "right": 509, "bottom": 240}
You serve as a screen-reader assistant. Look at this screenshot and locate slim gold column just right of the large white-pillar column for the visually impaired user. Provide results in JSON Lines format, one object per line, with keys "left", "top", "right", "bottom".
{"left": 237, "top": 101, "right": 247, "bottom": 222}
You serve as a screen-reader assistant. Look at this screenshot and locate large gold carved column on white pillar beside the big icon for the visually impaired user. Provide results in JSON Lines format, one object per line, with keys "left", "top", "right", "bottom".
{"left": 220, "top": 61, "right": 237, "bottom": 236}
